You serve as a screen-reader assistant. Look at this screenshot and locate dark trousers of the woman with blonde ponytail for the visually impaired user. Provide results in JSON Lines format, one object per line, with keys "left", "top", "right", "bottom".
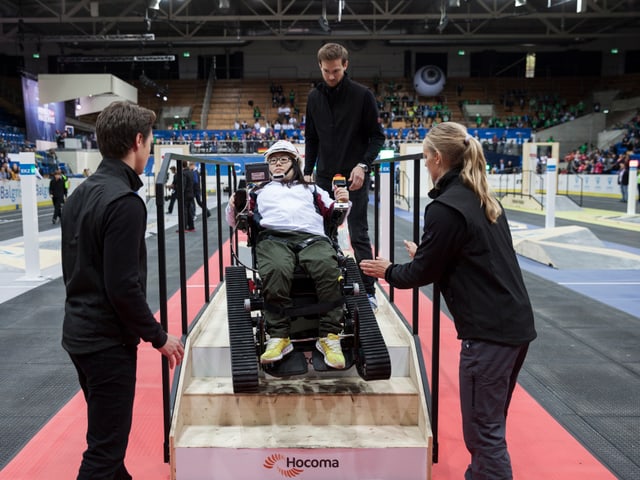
{"left": 459, "top": 340, "right": 529, "bottom": 480}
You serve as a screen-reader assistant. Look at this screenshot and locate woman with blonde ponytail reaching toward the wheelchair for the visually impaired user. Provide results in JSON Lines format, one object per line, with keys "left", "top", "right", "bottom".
{"left": 360, "top": 122, "right": 536, "bottom": 480}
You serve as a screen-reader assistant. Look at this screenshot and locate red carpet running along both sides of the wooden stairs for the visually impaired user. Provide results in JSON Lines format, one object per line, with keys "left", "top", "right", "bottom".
{"left": 0, "top": 246, "right": 615, "bottom": 480}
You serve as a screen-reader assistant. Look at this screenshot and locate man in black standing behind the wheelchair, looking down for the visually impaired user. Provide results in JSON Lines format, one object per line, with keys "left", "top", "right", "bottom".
{"left": 304, "top": 43, "right": 385, "bottom": 311}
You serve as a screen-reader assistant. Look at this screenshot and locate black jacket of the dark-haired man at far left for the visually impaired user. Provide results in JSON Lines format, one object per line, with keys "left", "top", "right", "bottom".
{"left": 62, "top": 159, "right": 167, "bottom": 354}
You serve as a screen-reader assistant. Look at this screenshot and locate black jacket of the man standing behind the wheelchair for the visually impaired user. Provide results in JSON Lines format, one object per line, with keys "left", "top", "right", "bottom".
{"left": 304, "top": 73, "right": 385, "bottom": 179}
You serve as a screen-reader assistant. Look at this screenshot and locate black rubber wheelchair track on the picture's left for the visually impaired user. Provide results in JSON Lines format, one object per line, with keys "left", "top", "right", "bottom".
{"left": 225, "top": 266, "right": 259, "bottom": 393}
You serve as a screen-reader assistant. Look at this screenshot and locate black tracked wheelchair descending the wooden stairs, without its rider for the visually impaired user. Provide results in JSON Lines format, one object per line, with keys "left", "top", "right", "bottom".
{"left": 225, "top": 163, "right": 391, "bottom": 393}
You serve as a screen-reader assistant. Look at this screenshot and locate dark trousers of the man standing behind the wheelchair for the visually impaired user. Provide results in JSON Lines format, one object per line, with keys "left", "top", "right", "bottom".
{"left": 317, "top": 175, "right": 375, "bottom": 294}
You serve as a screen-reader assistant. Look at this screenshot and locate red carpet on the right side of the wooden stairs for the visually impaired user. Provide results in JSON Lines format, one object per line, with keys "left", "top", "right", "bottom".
{"left": 384, "top": 289, "right": 615, "bottom": 480}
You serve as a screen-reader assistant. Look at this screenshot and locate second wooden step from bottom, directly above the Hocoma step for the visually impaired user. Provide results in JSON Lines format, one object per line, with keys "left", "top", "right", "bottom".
{"left": 181, "top": 377, "right": 420, "bottom": 428}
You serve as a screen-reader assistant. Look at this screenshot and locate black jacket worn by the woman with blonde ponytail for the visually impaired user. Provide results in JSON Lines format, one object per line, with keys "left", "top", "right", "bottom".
{"left": 385, "top": 170, "right": 536, "bottom": 345}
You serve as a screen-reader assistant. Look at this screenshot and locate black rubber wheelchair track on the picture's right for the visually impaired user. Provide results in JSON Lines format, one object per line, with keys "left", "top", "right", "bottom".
{"left": 346, "top": 258, "right": 391, "bottom": 381}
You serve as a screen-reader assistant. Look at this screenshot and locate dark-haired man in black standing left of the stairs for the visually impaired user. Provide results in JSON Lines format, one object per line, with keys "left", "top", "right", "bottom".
{"left": 62, "top": 102, "right": 184, "bottom": 480}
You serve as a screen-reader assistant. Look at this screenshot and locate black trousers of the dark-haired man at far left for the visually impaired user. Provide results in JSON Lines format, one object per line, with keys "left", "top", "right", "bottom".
{"left": 69, "top": 345, "right": 137, "bottom": 480}
